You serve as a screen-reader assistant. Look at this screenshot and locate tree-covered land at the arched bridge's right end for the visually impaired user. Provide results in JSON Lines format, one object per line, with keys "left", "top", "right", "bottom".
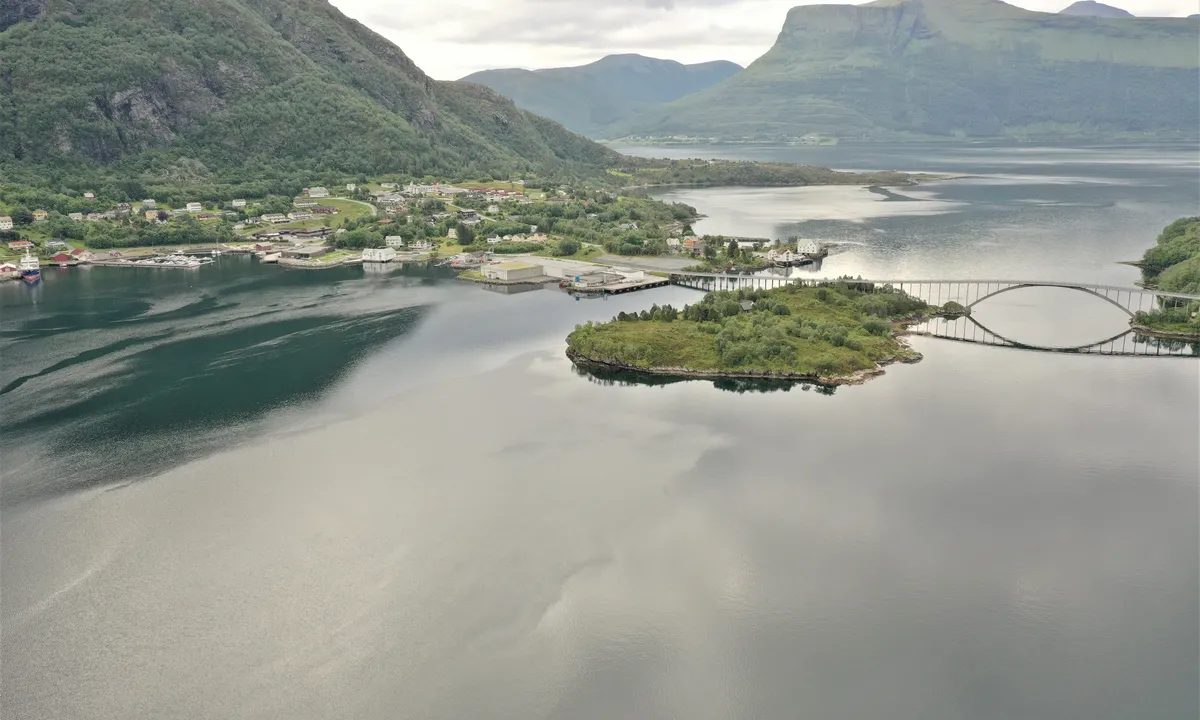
{"left": 1133, "top": 217, "right": 1200, "bottom": 337}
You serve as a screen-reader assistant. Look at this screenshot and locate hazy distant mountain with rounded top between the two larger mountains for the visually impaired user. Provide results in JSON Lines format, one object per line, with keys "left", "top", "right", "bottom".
{"left": 462, "top": 55, "right": 742, "bottom": 136}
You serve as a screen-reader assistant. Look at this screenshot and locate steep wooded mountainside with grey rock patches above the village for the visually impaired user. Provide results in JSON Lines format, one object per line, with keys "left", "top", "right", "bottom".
{"left": 0, "top": 0, "right": 617, "bottom": 178}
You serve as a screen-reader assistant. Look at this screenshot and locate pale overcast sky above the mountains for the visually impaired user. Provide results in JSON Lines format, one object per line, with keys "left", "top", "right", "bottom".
{"left": 331, "top": 0, "right": 1200, "bottom": 80}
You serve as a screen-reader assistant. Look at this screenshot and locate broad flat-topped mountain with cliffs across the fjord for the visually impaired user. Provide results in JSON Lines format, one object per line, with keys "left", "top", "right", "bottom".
{"left": 610, "top": 0, "right": 1200, "bottom": 139}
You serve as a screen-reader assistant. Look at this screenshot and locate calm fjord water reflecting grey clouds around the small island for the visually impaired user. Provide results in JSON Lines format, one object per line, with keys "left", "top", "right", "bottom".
{"left": 0, "top": 146, "right": 1200, "bottom": 719}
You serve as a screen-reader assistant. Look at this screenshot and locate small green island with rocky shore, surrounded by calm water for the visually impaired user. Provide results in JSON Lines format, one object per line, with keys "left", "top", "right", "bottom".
{"left": 566, "top": 280, "right": 945, "bottom": 385}
